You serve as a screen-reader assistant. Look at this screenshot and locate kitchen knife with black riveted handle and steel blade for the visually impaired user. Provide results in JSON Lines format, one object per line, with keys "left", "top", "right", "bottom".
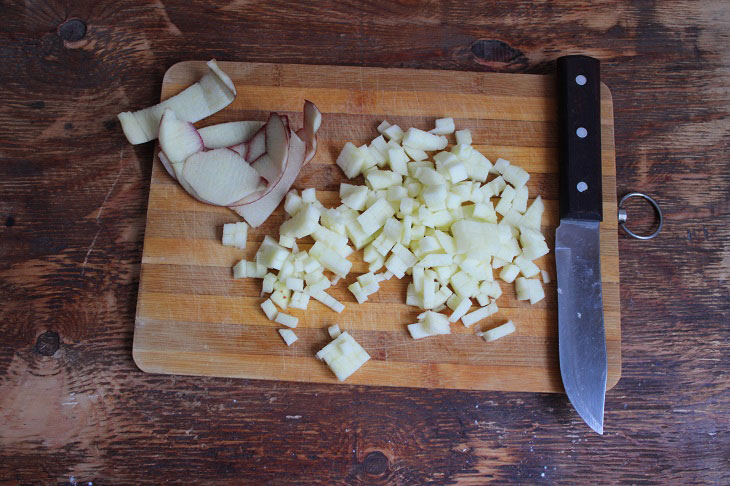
{"left": 555, "top": 56, "right": 607, "bottom": 434}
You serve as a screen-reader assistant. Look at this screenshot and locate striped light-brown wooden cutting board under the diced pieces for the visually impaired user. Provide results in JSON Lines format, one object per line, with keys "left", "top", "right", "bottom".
{"left": 134, "top": 61, "right": 621, "bottom": 392}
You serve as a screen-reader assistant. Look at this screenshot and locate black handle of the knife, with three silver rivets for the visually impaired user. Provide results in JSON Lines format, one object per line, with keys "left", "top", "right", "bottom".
{"left": 558, "top": 56, "right": 603, "bottom": 221}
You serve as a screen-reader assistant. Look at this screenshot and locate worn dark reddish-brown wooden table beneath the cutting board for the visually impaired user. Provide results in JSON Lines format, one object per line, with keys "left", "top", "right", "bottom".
{"left": 0, "top": 1, "right": 730, "bottom": 485}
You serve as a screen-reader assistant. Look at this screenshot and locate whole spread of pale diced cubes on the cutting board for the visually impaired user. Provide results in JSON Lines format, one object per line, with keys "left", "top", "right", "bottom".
{"left": 224, "top": 118, "right": 549, "bottom": 379}
